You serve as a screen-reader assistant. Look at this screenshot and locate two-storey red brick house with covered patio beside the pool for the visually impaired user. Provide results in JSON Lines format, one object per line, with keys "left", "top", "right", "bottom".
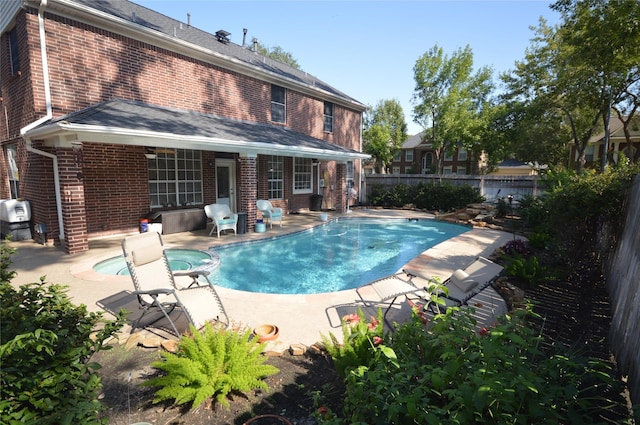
{"left": 0, "top": 0, "right": 369, "bottom": 253}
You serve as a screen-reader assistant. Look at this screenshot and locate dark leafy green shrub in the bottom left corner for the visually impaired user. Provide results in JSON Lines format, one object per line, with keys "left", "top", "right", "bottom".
{"left": 0, "top": 243, "right": 124, "bottom": 425}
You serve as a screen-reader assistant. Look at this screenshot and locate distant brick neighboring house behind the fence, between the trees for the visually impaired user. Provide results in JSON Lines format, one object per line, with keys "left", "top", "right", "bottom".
{"left": 390, "top": 132, "right": 474, "bottom": 175}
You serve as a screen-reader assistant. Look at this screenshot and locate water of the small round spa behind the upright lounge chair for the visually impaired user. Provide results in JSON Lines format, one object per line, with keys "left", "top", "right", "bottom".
{"left": 93, "top": 248, "right": 218, "bottom": 276}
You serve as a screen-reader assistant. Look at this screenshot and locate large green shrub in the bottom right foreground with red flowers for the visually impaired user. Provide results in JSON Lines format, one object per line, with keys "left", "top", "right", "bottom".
{"left": 330, "top": 309, "right": 616, "bottom": 424}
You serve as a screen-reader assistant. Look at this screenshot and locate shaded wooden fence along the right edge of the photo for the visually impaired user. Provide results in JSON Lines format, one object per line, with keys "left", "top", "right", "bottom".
{"left": 606, "top": 174, "right": 640, "bottom": 405}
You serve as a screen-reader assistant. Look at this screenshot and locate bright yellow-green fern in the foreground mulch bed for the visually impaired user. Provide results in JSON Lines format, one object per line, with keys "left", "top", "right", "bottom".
{"left": 143, "top": 324, "right": 279, "bottom": 410}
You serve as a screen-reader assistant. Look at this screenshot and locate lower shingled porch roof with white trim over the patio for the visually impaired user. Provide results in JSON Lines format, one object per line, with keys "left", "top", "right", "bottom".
{"left": 39, "top": 99, "right": 368, "bottom": 159}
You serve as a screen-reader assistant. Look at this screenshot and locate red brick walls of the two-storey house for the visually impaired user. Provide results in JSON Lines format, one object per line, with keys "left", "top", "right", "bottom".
{"left": 0, "top": 8, "right": 360, "bottom": 246}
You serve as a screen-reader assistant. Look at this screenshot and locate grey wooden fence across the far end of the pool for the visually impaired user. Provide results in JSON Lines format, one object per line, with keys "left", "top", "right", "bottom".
{"left": 361, "top": 174, "right": 541, "bottom": 204}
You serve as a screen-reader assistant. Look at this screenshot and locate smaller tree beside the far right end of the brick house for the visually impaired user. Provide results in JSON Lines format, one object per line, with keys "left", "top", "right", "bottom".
{"left": 362, "top": 99, "right": 407, "bottom": 173}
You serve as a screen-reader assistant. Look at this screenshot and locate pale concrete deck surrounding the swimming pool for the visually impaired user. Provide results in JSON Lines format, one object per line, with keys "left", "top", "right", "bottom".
{"left": 10, "top": 209, "right": 513, "bottom": 347}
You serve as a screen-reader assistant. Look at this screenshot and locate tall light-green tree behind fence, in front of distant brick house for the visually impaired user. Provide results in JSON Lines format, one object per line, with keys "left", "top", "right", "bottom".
{"left": 413, "top": 45, "right": 493, "bottom": 174}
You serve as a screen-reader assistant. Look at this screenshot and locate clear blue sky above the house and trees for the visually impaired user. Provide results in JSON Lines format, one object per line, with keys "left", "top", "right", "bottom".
{"left": 133, "top": 0, "right": 558, "bottom": 135}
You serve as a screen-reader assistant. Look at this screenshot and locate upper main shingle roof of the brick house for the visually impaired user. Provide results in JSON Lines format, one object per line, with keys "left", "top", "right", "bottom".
{"left": 73, "top": 0, "right": 364, "bottom": 106}
